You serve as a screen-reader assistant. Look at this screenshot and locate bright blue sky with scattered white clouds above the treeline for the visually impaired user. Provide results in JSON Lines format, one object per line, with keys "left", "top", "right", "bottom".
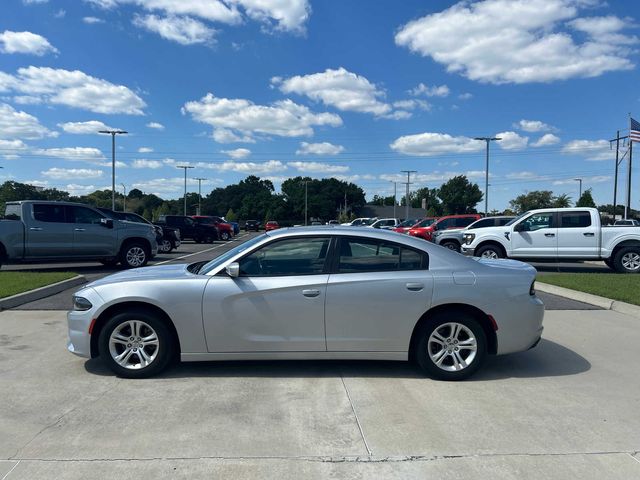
{"left": 0, "top": 0, "right": 640, "bottom": 209}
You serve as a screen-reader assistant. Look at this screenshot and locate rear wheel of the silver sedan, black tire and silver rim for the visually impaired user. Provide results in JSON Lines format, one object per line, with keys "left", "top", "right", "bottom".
{"left": 415, "top": 311, "right": 487, "bottom": 381}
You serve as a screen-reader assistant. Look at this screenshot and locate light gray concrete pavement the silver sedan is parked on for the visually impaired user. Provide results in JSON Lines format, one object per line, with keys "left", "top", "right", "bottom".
{"left": 0, "top": 310, "right": 640, "bottom": 480}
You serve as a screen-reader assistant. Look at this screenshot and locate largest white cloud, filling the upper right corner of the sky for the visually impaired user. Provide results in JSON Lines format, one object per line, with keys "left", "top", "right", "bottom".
{"left": 395, "top": 0, "right": 637, "bottom": 84}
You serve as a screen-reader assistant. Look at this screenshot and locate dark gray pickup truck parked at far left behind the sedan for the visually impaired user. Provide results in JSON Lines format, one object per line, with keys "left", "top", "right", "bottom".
{"left": 0, "top": 200, "right": 158, "bottom": 268}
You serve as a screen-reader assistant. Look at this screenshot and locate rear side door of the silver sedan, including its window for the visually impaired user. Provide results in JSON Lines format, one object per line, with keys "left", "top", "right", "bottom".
{"left": 325, "top": 237, "right": 433, "bottom": 352}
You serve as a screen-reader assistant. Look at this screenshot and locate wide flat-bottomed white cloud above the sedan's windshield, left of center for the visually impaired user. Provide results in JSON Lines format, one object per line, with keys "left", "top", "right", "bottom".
{"left": 182, "top": 93, "right": 342, "bottom": 138}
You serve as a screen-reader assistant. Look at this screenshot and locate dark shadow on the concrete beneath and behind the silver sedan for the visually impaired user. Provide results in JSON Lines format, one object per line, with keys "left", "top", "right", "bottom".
{"left": 85, "top": 339, "right": 591, "bottom": 381}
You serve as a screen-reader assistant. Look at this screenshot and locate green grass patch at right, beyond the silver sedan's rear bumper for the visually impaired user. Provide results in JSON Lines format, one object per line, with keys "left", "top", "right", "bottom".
{"left": 538, "top": 273, "right": 640, "bottom": 305}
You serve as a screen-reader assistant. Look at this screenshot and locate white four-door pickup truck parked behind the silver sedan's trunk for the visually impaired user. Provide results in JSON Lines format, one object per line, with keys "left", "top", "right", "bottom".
{"left": 461, "top": 208, "right": 640, "bottom": 273}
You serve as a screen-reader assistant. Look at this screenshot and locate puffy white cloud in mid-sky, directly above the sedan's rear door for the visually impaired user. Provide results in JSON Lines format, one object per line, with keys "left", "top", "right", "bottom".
{"left": 271, "top": 67, "right": 392, "bottom": 116}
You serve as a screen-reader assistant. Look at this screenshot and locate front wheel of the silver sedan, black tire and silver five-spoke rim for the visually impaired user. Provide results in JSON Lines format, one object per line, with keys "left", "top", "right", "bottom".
{"left": 98, "top": 310, "right": 175, "bottom": 378}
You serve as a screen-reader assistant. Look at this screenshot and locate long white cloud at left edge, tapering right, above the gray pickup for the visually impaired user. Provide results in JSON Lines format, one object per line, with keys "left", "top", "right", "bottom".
{"left": 0, "top": 66, "right": 146, "bottom": 115}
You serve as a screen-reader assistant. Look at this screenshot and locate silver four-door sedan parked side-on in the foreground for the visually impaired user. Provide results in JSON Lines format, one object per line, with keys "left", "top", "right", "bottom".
{"left": 68, "top": 226, "right": 544, "bottom": 380}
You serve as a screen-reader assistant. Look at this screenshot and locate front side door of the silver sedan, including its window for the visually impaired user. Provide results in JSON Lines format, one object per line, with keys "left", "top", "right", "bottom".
{"left": 202, "top": 236, "right": 330, "bottom": 352}
